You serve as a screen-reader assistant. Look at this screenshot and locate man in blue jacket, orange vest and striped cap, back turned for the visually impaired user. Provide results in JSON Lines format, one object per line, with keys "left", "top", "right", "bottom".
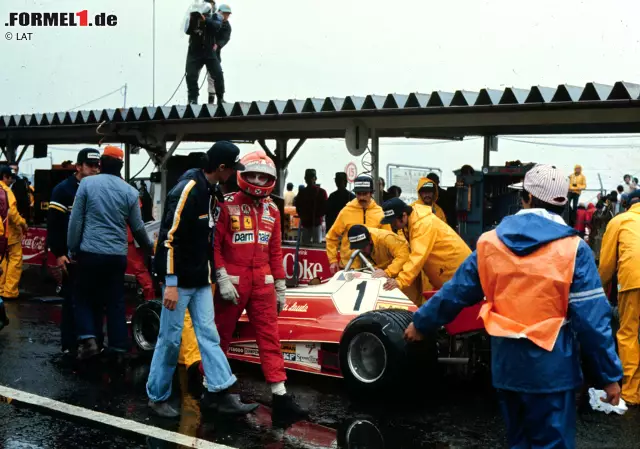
{"left": 405, "top": 165, "right": 622, "bottom": 449}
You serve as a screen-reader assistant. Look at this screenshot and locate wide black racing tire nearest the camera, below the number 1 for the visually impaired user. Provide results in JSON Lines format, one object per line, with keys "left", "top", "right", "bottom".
{"left": 340, "top": 309, "right": 438, "bottom": 393}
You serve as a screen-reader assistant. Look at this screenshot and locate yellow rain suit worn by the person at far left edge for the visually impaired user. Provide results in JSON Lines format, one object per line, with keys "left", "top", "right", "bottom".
{"left": 0, "top": 181, "right": 27, "bottom": 299}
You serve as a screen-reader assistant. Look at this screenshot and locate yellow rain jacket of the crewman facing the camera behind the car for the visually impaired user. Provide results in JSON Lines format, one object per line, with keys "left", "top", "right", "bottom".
{"left": 326, "top": 198, "right": 390, "bottom": 267}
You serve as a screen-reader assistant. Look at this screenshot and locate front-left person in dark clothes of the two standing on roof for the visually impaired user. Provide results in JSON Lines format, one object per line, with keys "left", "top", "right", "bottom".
{"left": 184, "top": 0, "right": 224, "bottom": 104}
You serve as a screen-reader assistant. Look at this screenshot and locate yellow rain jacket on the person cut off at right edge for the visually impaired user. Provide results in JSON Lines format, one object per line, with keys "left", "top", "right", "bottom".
{"left": 598, "top": 204, "right": 640, "bottom": 293}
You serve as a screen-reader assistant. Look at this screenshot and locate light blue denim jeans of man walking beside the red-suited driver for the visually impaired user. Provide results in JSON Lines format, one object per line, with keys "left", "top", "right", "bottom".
{"left": 147, "top": 285, "right": 237, "bottom": 402}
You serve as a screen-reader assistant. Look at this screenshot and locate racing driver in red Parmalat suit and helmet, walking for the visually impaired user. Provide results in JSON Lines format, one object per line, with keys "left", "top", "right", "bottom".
{"left": 213, "top": 150, "right": 306, "bottom": 418}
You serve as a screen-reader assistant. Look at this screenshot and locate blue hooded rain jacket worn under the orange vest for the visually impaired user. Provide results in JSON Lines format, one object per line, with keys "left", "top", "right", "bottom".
{"left": 413, "top": 209, "right": 622, "bottom": 393}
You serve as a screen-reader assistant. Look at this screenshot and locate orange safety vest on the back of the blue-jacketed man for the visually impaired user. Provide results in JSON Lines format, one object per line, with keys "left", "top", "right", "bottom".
{"left": 477, "top": 231, "right": 580, "bottom": 351}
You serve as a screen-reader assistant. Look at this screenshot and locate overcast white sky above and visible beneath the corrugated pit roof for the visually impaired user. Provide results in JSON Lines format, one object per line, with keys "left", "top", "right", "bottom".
{"left": 0, "top": 0, "right": 640, "bottom": 200}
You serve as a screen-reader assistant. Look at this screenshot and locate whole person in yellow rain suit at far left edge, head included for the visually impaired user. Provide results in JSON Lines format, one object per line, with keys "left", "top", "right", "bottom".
{"left": 0, "top": 165, "right": 29, "bottom": 301}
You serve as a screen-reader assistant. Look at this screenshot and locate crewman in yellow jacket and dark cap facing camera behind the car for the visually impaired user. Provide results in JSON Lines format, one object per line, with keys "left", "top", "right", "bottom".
{"left": 327, "top": 175, "right": 384, "bottom": 274}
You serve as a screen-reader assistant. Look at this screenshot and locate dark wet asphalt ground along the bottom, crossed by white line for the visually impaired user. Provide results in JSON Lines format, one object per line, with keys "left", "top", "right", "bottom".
{"left": 0, "top": 278, "right": 640, "bottom": 449}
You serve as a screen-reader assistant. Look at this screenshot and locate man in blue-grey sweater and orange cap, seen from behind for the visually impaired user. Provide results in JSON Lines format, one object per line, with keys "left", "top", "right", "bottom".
{"left": 67, "top": 145, "right": 153, "bottom": 360}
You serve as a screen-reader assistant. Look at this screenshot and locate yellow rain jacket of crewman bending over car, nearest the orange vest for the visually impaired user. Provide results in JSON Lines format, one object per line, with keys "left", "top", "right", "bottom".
{"left": 396, "top": 204, "right": 471, "bottom": 289}
